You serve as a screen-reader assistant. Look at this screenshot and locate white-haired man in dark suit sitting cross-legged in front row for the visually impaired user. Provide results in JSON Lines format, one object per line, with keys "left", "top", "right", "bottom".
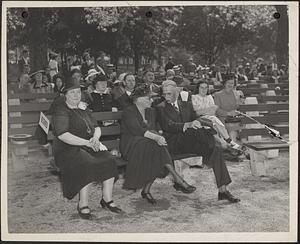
{"left": 156, "top": 80, "right": 240, "bottom": 202}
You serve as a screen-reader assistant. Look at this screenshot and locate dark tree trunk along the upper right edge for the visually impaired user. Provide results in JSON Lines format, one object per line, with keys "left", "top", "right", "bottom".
{"left": 275, "top": 5, "right": 289, "bottom": 65}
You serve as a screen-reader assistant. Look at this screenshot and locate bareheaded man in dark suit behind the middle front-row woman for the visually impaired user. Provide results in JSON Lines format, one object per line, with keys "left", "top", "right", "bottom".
{"left": 113, "top": 73, "right": 136, "bottom": 110}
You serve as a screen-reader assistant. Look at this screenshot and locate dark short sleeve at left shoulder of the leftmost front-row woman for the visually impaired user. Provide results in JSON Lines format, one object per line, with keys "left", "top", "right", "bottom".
{"left": 52, "top": 106, "right": 70, "bottom": 136}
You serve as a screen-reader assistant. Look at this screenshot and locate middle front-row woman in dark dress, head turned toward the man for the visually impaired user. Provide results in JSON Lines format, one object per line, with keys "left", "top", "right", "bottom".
{"left": 120, "top": 84, "right": 196, "bottom": 204}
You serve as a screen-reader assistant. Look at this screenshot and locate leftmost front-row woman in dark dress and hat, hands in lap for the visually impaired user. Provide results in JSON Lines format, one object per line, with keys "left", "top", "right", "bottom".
{"left": 52, "top": 80, "right": 121, "bottom": 219}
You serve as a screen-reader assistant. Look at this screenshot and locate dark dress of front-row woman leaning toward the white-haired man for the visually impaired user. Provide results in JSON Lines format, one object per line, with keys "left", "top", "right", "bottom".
{"left": 120, "top": 105, "right": 172, "bottom": 189}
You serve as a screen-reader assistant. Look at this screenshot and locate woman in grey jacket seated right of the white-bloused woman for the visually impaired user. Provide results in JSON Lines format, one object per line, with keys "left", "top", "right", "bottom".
{"left": 214, "top": 75, "right": 243, "bottom": 142}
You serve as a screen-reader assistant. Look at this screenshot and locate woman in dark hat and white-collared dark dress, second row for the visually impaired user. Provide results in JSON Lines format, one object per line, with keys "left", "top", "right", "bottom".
{"left": 89, "top": 74, "right": 117, "bottom": 112}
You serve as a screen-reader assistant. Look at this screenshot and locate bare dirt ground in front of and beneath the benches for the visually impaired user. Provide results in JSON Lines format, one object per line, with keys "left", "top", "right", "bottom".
{"left": 8, "top": 147, "right": 289, "bottom": 233}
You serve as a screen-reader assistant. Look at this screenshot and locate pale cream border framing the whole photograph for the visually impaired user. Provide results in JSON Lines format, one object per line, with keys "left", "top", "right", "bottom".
{"left": 1, "top": 1, "right": 299, "bottom": 242}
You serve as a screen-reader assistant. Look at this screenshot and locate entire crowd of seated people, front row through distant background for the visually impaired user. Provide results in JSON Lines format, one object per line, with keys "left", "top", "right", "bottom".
{"left": 7, "top": 48, "right": 287, "bottom": 218}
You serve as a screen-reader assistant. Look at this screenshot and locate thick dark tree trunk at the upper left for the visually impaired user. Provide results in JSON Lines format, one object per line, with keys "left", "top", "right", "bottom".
{"left": 26, "top": 8, "right": 48, "bottom": 72}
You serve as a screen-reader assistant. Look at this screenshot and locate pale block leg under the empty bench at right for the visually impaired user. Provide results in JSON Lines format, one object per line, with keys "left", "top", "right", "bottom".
{"left": 250, "top": 150, "right": 266, "bottom": 176}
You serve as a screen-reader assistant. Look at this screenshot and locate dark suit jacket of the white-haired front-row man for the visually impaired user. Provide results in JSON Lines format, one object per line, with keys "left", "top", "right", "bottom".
{"left": 156, "top": 100, "right": 196, "bottom": 143}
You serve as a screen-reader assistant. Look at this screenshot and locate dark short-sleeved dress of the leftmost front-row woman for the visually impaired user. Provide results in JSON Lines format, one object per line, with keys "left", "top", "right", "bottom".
{"left": 52, "top": 103, "right": 118, "bottom": 199}
